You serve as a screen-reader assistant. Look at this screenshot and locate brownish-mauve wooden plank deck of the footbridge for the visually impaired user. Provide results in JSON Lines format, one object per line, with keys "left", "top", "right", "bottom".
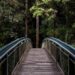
{"left": 12, "top": 48, "right": 64, "bottom": 75}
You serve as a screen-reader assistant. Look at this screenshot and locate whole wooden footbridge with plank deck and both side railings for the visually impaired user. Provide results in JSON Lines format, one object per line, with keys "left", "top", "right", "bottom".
{"left": 0, "top": 37, "right": 75, "bottom": 75}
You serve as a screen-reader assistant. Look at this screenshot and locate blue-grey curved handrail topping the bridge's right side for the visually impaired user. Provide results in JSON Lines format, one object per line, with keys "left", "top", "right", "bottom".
{"left": 44, "top": 37, "right": 75, "bottom": 60}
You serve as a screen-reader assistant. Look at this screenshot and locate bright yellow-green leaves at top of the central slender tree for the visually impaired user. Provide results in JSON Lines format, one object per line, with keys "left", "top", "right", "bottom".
{"left": 30, "top": 0, "right": 57, "bottom": 19}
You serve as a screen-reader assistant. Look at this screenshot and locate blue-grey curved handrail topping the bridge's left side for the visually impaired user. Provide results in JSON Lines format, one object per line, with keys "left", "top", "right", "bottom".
{"left": 0, "top": 37, "right": 28, "bottom": 60}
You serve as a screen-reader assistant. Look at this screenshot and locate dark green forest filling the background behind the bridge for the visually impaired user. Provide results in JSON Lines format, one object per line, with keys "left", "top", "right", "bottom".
{"left": 0, "top": 0, "right": 75, "bottom": 47}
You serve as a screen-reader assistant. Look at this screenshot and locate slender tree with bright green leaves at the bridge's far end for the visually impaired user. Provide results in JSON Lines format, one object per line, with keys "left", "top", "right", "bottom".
{"left": 30, "top": 0, "right": 56, "bottom": 47}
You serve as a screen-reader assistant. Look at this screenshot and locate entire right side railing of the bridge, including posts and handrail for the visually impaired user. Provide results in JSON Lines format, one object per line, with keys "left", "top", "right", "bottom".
{"left": 42, "top": 37, "right": 75, "bottom": 75}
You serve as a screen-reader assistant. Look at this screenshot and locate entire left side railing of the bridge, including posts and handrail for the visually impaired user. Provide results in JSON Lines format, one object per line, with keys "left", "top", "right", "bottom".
{"left": 0, "top": 37, "right": 32, "bottom": 75}
